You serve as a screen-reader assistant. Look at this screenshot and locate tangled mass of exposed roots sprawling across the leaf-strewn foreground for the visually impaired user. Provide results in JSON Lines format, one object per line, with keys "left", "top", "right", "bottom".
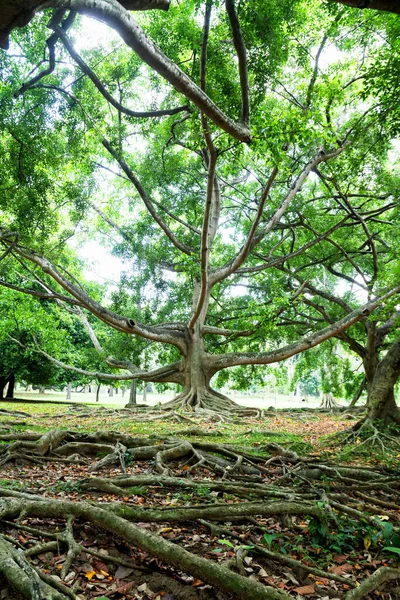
{"left": 0, "top": 422, "right": 400, "bottom": 600}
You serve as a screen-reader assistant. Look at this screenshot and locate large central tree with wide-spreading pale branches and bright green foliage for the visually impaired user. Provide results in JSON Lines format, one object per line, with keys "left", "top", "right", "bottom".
{"left": 2, "top": 0, "right": 399, "bottom": 418}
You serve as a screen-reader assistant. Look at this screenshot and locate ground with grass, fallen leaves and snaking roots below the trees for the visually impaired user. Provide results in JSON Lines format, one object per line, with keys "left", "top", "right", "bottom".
{"left": 0, "top": 403, "right": 400, "bottom": 600}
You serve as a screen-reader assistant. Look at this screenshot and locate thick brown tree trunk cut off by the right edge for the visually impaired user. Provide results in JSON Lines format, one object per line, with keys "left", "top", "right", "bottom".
{"left": 366, "top": 337, "right": 400, "bottom": 426}
